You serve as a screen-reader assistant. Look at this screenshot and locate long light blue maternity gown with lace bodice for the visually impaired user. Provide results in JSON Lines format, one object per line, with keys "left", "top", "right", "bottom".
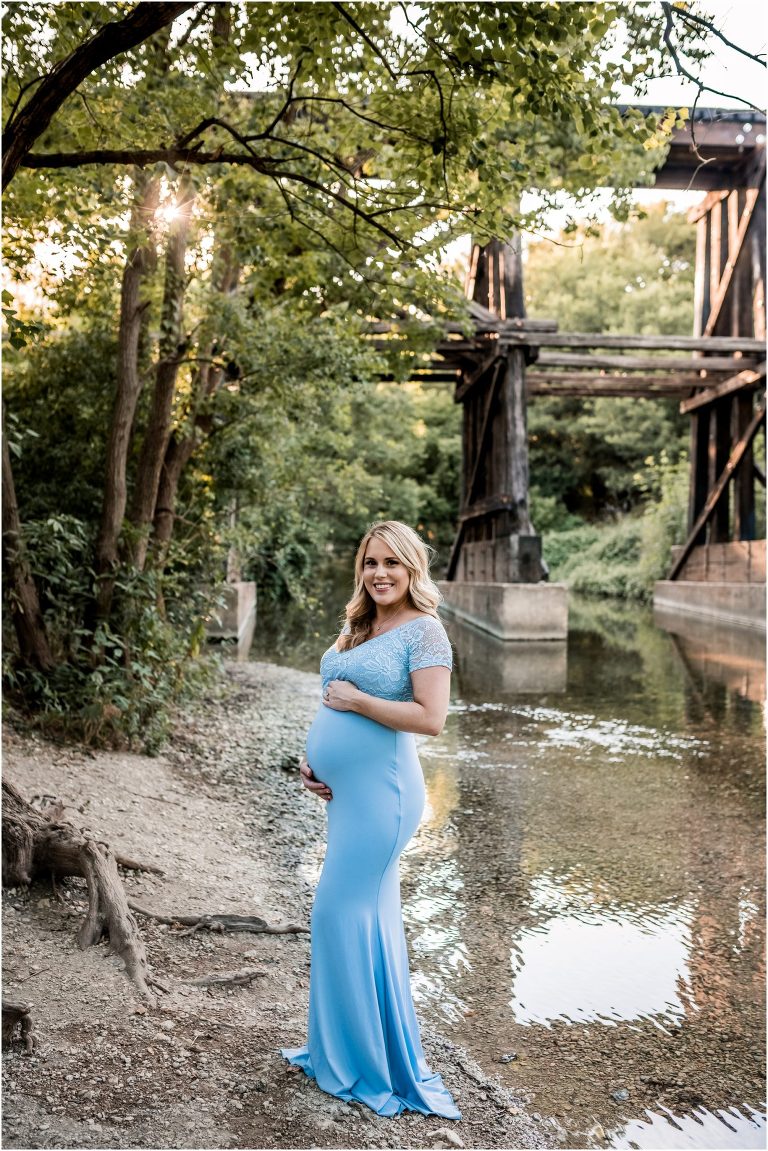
{"left": 281, "top": 616, "right": 462, "bottom": 1119}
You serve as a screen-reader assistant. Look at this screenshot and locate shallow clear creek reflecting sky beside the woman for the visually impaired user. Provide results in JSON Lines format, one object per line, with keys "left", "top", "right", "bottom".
{"left": 252, "top": 595, "right": 766, "bottom": 1149}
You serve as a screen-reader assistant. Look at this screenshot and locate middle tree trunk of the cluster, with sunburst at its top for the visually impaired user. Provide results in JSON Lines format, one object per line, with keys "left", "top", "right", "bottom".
{"left": 131, "top": 176, "right": 195, "bottom": 571}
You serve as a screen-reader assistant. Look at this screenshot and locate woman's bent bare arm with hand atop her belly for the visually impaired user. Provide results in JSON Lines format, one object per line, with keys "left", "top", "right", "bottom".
{"left": 322, "top": 666, "right": 450, "bottom": 735}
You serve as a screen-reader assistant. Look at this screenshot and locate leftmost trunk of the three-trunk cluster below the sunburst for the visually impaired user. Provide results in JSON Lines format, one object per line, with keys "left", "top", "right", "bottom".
{"left": 90, "top": 170, "right": 160, "bottom": 619}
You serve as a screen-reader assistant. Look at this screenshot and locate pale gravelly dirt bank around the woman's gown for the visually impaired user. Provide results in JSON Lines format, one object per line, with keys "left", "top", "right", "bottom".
{"left": 2, "top": 663, "right": 552, "bottom": 1148}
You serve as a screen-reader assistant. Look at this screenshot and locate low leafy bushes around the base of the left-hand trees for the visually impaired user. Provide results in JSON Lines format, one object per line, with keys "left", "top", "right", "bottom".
{"left": 3, "top": 516, "right": 222, "bottom": 753}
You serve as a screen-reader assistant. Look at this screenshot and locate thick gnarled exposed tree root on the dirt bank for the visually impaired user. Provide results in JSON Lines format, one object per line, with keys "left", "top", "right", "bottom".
{"left": 2, "top": 780, "right": 167, "bottom": 1004}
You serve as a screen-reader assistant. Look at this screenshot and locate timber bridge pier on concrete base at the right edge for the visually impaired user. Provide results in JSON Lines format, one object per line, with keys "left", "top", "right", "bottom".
{"left": 654, "top": 127, "right": 766, "bottom": 628}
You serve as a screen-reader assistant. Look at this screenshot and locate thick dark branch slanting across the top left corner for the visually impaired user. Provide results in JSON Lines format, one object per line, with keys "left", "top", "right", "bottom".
{"left": 2, "top": 0, "right": 192, "bottom": 186}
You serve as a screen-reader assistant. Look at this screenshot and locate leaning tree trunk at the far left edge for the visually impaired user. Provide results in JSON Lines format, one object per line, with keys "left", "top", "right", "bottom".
{"left": 2, "top": 407, "right": 54, "bottom": 672}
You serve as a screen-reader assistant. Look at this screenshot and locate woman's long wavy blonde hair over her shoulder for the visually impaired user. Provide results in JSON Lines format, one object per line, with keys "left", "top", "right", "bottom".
{"left": 339, "top": 519, "right": 442, "bottom": 651}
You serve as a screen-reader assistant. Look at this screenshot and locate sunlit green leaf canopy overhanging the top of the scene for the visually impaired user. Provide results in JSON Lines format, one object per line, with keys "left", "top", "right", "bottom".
{"left": 3, "top": 0, "right": 695, "bottom": 292}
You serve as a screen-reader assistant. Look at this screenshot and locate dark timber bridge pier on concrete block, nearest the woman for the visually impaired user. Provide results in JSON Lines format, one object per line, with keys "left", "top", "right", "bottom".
{"left": 442, "top": 237, "right": 568, "bottom": 641}
